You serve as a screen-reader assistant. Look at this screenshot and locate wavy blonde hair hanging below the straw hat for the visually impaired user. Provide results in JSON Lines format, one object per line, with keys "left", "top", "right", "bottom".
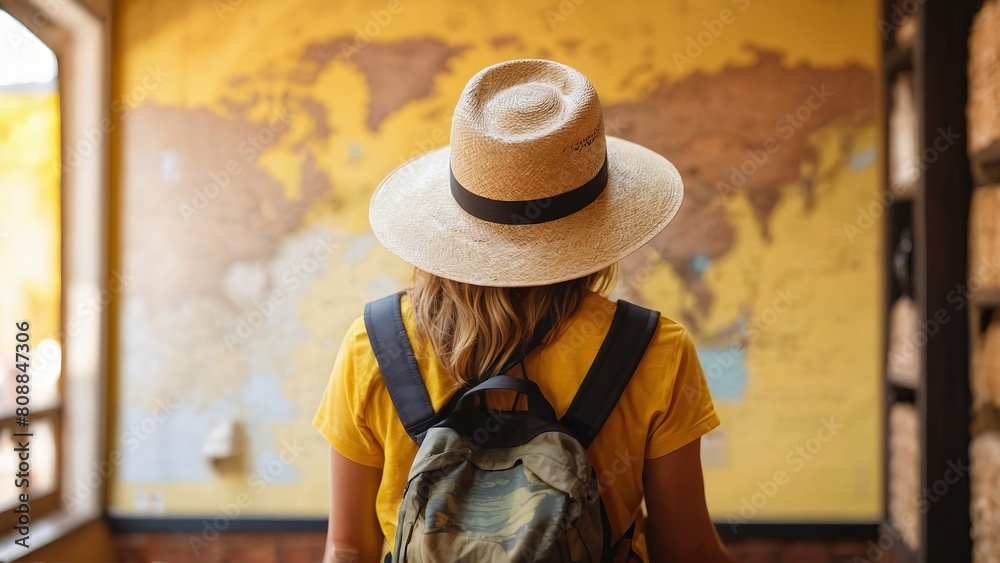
{"left": 409, "top": 265, "right": 618, "bottom": 385}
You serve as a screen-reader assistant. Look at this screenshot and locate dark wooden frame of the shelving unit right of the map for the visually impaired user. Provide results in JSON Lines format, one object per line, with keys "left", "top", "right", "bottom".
{"left": 881, "top": 0, "right": 972, "bottom": 563}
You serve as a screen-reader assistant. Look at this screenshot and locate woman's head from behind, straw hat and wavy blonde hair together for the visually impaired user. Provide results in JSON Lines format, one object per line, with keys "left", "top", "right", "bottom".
{"left": 376, "top": 59, "right": 684, "bottom": 383}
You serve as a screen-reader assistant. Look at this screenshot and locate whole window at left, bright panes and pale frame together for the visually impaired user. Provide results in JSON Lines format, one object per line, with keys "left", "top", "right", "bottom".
{"left": 0, "top": 0, "right": 114, "bottom": 561}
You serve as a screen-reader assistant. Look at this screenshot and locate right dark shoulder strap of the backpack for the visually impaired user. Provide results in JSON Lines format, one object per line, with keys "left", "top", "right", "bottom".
{"left": 562, "top": 300, "right": 660, "bottom": 448}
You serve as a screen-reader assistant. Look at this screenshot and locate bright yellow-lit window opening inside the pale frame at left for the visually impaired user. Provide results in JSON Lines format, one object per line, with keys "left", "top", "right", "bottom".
{"left": 0, "top": 7, "right": 62, "bottom": 529}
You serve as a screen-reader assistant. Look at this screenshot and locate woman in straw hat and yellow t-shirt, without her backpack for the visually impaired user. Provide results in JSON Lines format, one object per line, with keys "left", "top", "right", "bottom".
{"left": 314, "top": 60, "right": 730, "bottom": 562}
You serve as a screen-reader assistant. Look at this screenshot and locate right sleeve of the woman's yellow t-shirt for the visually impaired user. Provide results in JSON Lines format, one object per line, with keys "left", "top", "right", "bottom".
{"left": 645, "top": 330, "right": 719, "bottom": 459}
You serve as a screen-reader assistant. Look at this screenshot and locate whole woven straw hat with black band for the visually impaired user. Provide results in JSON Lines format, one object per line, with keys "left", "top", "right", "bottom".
{"left": 369, "top": 60, "right": 683, "bottom": 287}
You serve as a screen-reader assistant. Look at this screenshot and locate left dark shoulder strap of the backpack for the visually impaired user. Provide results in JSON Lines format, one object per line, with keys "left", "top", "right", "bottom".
{"left": 365, "top": 292, "right": 436, "bottom": 444}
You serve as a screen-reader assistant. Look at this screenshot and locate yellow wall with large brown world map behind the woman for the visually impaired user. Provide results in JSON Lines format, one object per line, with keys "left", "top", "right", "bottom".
{"left": 111, "top": 0, "right": 881, "bottom": 521}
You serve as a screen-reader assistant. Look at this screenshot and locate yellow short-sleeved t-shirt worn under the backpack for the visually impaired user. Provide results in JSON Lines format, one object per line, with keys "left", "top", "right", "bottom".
{"left": 313, "top": 293, "right": 719, "bottom": 561}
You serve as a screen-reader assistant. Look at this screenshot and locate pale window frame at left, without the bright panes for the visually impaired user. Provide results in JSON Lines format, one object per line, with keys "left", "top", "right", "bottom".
{"left": 0, "top": 0, "right": 114, "bottom": 561}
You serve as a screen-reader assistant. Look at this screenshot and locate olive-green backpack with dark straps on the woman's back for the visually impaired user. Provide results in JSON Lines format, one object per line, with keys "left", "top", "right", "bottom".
{"left": 364, "top": 293, "right": 660, "bottom": 563}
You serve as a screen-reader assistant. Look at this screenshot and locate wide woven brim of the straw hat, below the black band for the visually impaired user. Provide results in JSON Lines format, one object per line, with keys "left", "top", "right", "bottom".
{"left": 368, "top": 137, "right": 684, "bottom": 287}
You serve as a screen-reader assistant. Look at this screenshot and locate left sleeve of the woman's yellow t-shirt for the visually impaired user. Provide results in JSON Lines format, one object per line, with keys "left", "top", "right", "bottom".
{"left": 313, "top": 321, "right": 385, "bottom": 468}
